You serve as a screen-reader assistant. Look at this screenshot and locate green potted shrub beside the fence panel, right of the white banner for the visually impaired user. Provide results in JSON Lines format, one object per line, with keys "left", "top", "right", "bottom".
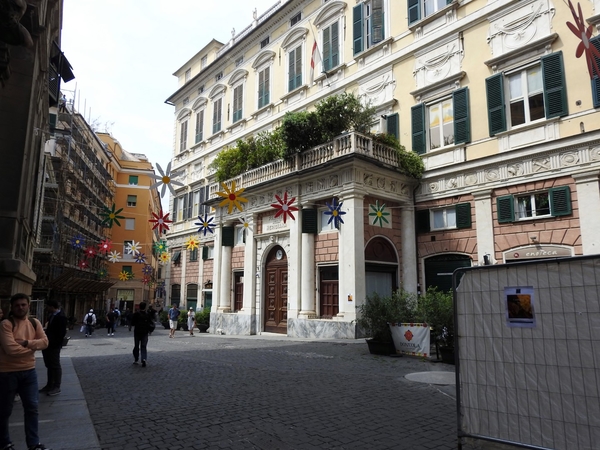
{"left": 419, "top": 288, "right": 454, "bottom": 364}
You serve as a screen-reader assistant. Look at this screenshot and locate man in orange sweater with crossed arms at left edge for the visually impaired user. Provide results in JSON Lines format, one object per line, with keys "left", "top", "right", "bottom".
{"left": 0, "top": 294, "right": 48, "bottom": 450}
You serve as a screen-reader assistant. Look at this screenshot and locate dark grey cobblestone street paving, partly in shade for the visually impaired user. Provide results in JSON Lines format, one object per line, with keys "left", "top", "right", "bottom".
{"left": 63, "top": 328, "right": 456, "bottom": 450}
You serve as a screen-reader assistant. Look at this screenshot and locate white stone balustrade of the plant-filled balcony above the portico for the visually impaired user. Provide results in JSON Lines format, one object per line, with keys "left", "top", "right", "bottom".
{"left": 209, "top": 132, "right": 399, "bottom": 198}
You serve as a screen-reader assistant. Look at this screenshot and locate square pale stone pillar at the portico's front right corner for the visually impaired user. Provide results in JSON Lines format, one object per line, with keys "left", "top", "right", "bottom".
{"left": 338, "top": 194, "right": 366, "bottom": 321}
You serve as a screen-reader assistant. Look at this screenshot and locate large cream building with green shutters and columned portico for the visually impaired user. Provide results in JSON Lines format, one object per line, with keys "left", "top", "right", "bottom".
{"left": 167, "top": 0, "right": 600, "bottom": 338}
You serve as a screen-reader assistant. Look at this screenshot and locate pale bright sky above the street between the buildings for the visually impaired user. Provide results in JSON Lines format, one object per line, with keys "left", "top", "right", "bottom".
{"left": 61, "top": 0, "right": 283, "bottom": 207}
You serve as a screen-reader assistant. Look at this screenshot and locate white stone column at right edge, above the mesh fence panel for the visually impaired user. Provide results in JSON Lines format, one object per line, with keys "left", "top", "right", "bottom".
{"left": 573, "top": 170, "right": 600, "bottom": 255}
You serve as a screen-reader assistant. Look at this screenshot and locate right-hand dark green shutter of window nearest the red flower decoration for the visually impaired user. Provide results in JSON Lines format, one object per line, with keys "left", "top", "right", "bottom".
{"left": 540, "top": 52, "right": 569, "bottom": 119}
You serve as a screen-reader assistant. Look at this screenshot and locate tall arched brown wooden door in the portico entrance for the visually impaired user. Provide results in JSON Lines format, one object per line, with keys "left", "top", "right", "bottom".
{"left": 264, "top": 246, "right": 288, "bottom": 334}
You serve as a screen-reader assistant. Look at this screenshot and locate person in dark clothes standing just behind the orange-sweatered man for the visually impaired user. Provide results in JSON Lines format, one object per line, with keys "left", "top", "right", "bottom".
{"left": 40, "top": 300, "right": 67, "bottom": 396}
